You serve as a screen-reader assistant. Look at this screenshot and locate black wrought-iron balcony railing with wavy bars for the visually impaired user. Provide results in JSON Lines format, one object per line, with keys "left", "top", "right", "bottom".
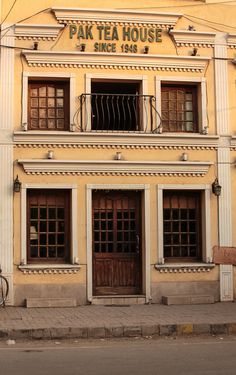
{"left": 76, "top": 93, "right": 157, "bottom": 133}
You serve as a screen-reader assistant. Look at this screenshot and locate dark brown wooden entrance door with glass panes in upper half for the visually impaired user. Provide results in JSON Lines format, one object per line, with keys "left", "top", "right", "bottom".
{"left": 93, "top": 191, "right": 142, "bottom": 295}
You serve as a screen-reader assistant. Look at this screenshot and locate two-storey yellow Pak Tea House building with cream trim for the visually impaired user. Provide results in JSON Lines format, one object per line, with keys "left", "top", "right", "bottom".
{"left": 0, "top": 0, "right": 236, "bottom": 306}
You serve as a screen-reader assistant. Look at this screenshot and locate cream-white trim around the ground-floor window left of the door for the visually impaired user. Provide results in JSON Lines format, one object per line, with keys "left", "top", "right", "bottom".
{"left": 21, "top": 183, "right": 78, "bottom": 268}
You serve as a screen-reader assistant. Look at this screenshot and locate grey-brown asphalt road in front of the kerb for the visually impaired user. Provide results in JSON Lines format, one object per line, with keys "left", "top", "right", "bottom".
{"left": 0, "top": 336, "right": 236, "bottom": 375}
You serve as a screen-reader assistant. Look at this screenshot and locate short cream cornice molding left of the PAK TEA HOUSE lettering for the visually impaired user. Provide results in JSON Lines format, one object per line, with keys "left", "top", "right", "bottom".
{"left": 14, "top": 23, "right": 65, "bottom": 40}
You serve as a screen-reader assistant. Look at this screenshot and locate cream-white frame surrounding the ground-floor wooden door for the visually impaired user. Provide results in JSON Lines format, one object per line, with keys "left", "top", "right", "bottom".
{"left": 86, "top": 184, "right": 151, "bottom": 303}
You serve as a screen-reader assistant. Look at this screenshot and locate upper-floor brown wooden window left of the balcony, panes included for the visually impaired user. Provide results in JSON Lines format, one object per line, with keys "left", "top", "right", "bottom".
{"left": 28, "top": 80, "right": 69, "bottom": 131}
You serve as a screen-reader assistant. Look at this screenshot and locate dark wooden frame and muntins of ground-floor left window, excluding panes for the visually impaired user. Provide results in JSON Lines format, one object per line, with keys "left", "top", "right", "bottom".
{"left": 26, "top": 189, "right": 71, "bottom": 264}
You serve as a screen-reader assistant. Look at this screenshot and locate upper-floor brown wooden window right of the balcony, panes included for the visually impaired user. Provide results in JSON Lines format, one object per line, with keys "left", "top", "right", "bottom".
{"left": 161, "top": 84, "right": 199, "bottom": 133}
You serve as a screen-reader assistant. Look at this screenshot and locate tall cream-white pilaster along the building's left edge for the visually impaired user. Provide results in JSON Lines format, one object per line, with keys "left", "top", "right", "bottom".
{"left": 0, "top": 24, "right": 14, "bottom": 304}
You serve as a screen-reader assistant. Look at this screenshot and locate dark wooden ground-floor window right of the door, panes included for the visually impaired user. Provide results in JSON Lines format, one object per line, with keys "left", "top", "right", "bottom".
{"left": 163, "top": 190, "right": 202, "bottom": 262}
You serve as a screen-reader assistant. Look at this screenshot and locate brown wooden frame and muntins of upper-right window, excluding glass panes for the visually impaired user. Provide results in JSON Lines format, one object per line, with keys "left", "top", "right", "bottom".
{"left": 161, "top": 83, "right": 199, "bottom": 133}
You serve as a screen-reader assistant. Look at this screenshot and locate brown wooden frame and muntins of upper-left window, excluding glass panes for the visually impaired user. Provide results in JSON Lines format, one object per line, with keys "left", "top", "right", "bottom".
{"left": 28, "top": 79, "right": 70, "bottom": 131}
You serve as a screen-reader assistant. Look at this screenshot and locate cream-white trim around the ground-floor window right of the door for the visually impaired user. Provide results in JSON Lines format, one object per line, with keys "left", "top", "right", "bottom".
{"left": 157, "top": 184, "right": 212, "bottom": 264}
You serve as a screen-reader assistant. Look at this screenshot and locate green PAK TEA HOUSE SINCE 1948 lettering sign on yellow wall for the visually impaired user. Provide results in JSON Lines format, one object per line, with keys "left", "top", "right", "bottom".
{"left": 69, "top": 25, "right": 162, "bottom": 53}
